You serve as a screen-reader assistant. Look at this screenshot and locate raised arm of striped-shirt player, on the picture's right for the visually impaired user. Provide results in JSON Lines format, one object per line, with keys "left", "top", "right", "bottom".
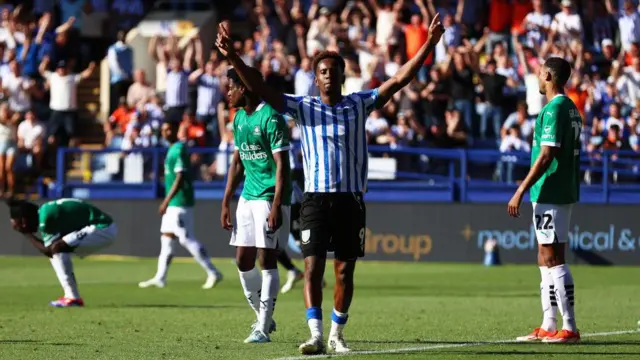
{"left": 376, "top": 14, "right": 444, "bottom": 108}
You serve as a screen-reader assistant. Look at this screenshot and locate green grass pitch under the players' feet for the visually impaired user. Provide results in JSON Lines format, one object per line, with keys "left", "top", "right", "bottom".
{"left": 0, "top": 258, "right": 640, "bottom": 360}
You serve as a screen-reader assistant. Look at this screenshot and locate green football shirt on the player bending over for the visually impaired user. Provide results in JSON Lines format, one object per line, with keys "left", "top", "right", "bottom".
{"left": 38, "top": 199, "right": 113, "bottom": 246}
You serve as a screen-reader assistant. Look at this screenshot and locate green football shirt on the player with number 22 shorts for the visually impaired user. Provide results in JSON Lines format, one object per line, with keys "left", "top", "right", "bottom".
{"left": 529, "top": 95, "right": 582, "bottom": 205}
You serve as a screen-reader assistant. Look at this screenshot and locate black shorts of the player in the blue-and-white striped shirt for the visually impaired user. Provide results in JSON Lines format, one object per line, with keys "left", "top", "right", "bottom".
{"left": 300, "top": 193, "right": 366, "bottom": 261}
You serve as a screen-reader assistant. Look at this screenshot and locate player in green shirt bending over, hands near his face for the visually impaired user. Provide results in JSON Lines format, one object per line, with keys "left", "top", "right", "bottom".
{"left": 8, "top": 199, "right": 118, "bottom": 307}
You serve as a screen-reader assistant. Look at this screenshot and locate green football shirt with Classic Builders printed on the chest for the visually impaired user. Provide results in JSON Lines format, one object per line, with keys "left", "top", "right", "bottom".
{"left": 233, "top": 103, "right": 292, "bottom": 205}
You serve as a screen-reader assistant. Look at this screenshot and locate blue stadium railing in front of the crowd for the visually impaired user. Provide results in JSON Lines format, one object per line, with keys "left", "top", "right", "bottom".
{"left": 48, "top": 146, "right": 640, "bottom": 204}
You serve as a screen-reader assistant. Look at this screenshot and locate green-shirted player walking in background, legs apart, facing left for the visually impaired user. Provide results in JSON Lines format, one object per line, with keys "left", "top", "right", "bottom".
{"left": 138, "top": 122, "right": 222, "bottom": 289}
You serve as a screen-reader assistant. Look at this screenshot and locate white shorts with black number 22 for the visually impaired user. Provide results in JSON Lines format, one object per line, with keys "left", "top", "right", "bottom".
{"left": 532, "top": 203, "right": 573, "bottom": 245}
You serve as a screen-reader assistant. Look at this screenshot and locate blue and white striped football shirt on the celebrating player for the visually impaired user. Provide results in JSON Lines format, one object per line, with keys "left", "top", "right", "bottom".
{"left": 284, "top": 89, "right": 378, "bottom": 193}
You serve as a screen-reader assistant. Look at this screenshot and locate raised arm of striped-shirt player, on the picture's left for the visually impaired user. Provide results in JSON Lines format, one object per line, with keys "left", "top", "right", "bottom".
{"left": 216, "top": 22, "right": 285, "bottom": 113}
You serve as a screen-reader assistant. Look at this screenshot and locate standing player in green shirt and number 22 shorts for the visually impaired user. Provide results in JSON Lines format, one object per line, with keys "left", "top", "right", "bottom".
{"left": 508, "top": 57, "right": 582, "bottom": 343}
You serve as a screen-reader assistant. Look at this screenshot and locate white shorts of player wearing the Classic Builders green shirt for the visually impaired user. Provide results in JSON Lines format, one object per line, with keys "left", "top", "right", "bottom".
{"left": 229, "top": 197, "right": 291, "bottom": 249}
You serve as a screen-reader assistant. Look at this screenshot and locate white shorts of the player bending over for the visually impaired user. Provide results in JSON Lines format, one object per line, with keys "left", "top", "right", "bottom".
{"left": 62, "top": 223, "right": 118, "bottom": 257}
